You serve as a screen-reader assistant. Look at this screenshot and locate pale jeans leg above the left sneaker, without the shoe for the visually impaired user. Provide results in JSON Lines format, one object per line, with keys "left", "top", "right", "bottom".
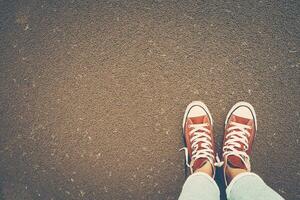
{"left": 179, "top": 172, "right": 220, "bottom": 200}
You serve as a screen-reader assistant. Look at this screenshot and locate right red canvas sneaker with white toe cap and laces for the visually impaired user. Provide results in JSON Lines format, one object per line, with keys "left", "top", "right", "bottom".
{"left": 223, "top": 102, "right": 257, "bottom": 185}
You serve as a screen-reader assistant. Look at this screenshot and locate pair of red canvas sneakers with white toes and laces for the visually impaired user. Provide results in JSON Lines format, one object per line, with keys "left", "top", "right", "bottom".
{"left": 182, "top": 101, "right": 257, "bottom": 184}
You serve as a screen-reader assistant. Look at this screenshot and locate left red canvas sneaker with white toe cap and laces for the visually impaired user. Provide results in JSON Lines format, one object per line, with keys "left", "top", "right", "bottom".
{"left": 181, "top": 101, "right": 219, "bottom": 177}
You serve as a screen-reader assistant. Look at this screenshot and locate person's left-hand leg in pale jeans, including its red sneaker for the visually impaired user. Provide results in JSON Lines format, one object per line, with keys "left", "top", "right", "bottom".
{"left": 179, "top": 101, "right": 220, "bottom": 200}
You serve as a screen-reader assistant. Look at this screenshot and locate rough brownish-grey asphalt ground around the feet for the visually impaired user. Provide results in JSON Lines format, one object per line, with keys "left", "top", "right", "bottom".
{"left": 0, "top": 0, "right": 300, "bottom": 200}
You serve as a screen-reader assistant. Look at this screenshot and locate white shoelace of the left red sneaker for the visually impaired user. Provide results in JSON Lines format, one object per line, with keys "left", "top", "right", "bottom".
{"left": 179, "top": 123, "right": 222, "bottom": 173}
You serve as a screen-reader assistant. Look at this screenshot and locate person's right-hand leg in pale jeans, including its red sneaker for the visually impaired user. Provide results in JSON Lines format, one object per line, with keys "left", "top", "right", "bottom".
{"left": 223, "top": 102, "right": 283, "bottom": 200}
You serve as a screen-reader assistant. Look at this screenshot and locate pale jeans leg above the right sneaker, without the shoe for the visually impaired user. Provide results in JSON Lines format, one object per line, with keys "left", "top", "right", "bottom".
{"left": 226, "top": 172, "right": 283, "bottom": 200}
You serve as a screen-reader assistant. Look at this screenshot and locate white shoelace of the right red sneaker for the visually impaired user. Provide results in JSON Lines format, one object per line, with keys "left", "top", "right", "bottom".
{"left": 223, "top": 122, "right": 251, "bottom": 170}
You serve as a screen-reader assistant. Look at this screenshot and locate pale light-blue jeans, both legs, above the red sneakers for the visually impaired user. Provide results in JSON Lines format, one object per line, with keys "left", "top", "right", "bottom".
{"left": 179, "top": 172, "right": 283, "bottom": 200}
